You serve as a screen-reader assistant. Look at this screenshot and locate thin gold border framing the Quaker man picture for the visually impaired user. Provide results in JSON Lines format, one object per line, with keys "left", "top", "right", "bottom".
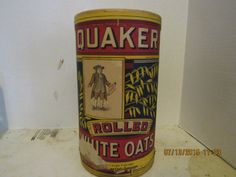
{"left": 79, "top": 57, "right": 125, "bottom": 120}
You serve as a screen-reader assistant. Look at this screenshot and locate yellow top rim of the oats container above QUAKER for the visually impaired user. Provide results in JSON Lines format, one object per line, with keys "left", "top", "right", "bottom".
{"left": 74, "top": 9, "right": 161, "bottom": 24}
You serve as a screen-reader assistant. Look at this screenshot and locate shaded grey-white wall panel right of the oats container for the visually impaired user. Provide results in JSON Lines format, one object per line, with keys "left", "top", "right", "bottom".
{"left": 180, "top": 0, "right": 236, "bottom": 167}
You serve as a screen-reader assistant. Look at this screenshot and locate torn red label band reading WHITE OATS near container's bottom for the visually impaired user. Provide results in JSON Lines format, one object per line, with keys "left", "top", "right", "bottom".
{"left": 80, "top": 128, "right": 155, "bottom": 162}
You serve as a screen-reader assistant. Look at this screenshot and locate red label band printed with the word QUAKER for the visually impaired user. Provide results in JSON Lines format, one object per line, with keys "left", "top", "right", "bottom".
{"left": 75, "top": 20, "right": 160, "bottom": 55}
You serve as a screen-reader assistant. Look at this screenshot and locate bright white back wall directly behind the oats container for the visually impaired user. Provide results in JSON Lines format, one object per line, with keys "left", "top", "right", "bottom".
{"left": 0, "top": 0, "right": 188, "bottom": 128}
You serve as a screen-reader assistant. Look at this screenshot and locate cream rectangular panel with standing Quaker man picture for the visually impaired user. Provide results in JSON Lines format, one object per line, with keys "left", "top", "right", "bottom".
{"left": 83, "top": 59, "right": 123, "bottom": 119}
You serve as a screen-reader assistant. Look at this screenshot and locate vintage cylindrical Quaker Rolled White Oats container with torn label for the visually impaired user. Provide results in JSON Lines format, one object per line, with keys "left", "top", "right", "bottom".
{"left": 75, "top": 9, "right": 161, "bottom": 177}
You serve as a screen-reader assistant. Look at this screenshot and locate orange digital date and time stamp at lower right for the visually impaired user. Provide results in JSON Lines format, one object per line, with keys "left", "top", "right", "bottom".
{"left": 164, "top": 148, "right": 222, "bottom": 156}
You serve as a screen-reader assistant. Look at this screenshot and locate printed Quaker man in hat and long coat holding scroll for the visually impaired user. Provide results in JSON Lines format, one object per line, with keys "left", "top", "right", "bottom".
{"left": 88, "top": 65, "right": 116, "bottom": 110}
